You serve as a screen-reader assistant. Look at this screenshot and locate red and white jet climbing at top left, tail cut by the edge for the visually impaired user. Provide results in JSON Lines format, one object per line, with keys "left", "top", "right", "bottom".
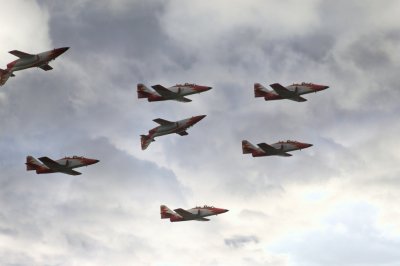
{"left": 0, "top": 47, "right": 69, "bottom": 86}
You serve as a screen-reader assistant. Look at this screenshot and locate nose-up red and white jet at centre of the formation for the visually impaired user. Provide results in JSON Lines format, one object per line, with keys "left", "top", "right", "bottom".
{"left": 140, "top": 115, "right": 206, "bottom": 150}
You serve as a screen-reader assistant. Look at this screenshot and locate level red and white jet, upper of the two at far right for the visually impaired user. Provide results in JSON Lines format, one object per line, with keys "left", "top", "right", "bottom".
{"left": 254, "top": 82, "right": 329, "bottom": 102}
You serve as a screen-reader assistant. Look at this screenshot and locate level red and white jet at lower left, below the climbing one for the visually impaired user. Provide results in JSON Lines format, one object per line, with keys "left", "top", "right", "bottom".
{"left": 25, "top": 156, "right": 99, "bottom": 175}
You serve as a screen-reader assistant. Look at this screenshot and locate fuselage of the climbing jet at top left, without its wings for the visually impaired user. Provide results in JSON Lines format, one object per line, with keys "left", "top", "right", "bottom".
{"left": 7, "top": 47, "right": 68, "bottom": 73}
